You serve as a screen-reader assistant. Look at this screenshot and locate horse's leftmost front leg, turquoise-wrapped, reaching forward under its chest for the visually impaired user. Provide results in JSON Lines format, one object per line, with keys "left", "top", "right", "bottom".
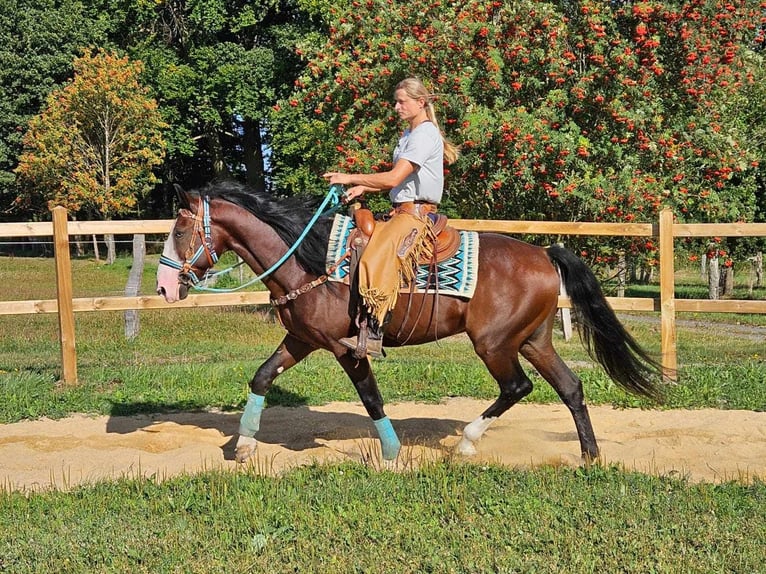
{"left": 234, "top": 333, "right": 316, "bottom": 462}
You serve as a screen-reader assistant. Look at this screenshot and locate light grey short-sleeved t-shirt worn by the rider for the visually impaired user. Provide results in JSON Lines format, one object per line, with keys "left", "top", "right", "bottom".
{"left": 389, "top": 122, "right": 444, "bottom": 203}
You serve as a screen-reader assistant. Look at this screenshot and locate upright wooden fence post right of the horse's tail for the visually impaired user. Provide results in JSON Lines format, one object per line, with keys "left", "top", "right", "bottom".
{"left": 659, "top": 209, "right": 678, "bottom": 380}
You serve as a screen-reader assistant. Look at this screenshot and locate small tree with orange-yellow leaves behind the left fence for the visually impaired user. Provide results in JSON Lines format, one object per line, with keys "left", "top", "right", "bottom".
{"left": 16, "top": 51, "right": 165, "bottom": 258}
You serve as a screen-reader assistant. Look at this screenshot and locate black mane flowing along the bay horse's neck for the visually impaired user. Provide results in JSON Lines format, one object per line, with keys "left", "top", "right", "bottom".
{"left": 193, "top": 180, "right": 333, "bottom": 276}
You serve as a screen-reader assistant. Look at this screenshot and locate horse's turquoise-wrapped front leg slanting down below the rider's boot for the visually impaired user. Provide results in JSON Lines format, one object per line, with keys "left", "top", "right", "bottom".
{"left": 337, "top": 353, "right": 402, "bottom": 462}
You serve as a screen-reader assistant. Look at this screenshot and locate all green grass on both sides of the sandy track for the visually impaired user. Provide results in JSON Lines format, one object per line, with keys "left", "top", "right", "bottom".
{"left": 0, "top": 258, "right": 766, "bottom": 573}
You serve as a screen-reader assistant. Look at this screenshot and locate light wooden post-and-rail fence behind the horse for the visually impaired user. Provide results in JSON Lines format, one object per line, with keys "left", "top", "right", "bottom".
{"left": 0, "top": 207, "right": 766, "bottom": 384}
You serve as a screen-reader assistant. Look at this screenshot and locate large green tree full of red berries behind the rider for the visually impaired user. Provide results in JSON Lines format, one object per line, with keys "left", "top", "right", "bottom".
{"left": 271, "top": 0, "right": 766, "bottom": 253}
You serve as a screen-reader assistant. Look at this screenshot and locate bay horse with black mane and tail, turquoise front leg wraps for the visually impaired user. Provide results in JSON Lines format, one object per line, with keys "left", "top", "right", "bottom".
{"left": 157, "top": 181, "right": 663, "bottom": 463}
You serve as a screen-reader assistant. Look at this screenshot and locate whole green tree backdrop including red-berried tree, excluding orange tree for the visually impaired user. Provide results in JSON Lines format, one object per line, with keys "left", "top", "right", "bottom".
{"left": 6, "top": 0, "right": 766, "bottom": 236}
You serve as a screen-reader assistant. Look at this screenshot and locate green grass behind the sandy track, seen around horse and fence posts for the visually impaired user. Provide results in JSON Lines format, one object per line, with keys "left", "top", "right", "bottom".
{"left": 0, "top": 257, "right": 766, "bottom": 423}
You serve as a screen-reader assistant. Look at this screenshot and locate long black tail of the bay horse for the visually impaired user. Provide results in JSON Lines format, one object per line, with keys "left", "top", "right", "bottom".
{"left": 548, "top": 245, "right": 662, "bottom": 400}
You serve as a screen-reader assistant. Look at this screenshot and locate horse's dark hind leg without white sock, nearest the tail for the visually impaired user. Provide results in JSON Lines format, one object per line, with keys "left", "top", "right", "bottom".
{"left": 521, "top": 331, "right": 599, "bottom": 463}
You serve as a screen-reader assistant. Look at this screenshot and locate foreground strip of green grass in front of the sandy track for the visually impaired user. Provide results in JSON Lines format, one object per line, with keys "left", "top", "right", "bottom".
{"left": 0, "top": 461, "right": 766, "bottom": 574}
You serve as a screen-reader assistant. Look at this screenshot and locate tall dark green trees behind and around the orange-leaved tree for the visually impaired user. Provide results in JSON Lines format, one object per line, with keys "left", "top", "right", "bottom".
{"left": 0, "top": 0, "right": 326, "bottom": 220}
